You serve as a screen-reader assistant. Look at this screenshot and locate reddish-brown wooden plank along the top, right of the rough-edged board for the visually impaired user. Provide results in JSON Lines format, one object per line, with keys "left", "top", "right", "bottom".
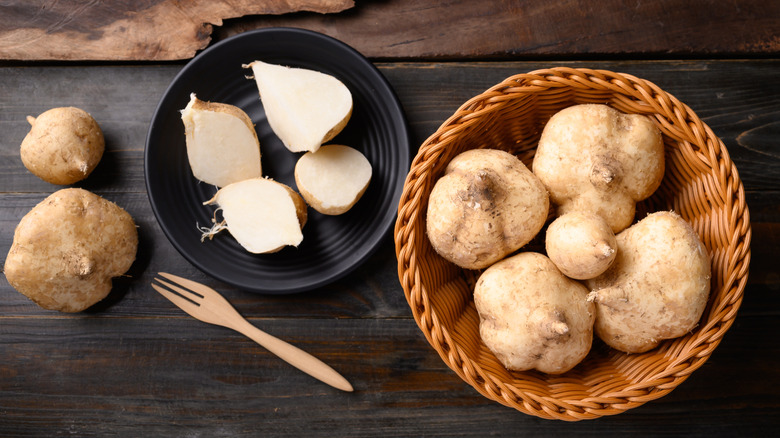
{"left": 215, "top": 0, "right": 780, "bottom": 59}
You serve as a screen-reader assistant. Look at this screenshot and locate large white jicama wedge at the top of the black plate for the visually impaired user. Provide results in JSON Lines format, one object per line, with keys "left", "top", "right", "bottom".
{"left": 244, "top": 61, "right": 352, "bottom": 152}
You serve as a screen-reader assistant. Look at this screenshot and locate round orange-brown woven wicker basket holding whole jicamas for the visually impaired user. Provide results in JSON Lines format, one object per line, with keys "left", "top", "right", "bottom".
{"left": 395, "top": 68, "right": 751, "bottom": 421}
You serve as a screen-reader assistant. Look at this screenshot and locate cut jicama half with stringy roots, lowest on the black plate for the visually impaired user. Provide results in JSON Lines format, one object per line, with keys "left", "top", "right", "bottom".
{"left": 201, "top": 178, "right": 307, "bottom": 254}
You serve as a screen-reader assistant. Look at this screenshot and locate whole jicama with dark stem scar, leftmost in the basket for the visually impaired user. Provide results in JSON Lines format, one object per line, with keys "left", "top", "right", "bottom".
{"left": 426, "top": 149, "right": 549, "bottom": 269}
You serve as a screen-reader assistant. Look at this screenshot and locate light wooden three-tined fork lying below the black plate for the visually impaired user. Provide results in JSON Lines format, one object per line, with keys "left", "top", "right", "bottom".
{"left": 152, "top": 272, "right": 352, "bottom": 392}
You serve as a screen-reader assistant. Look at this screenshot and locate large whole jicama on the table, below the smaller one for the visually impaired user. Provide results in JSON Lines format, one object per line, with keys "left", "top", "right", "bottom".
{"left": 4, "top": 188, "right": 138, "bottom": 312}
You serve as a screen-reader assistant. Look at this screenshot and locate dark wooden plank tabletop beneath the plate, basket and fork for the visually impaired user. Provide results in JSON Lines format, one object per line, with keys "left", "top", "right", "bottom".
{"left": 0, "top": 1, "right": 780, "bottom": 437}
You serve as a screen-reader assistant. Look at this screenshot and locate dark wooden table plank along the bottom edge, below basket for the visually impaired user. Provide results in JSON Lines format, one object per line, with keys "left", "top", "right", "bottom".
{"left": 0, "top": 302, "right": 780, "bottom": 437}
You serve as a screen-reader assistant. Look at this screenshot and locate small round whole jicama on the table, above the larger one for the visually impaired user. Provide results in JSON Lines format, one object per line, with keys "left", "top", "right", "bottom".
{"left": 20, "top": 107, "right": 105, "bottom": 185}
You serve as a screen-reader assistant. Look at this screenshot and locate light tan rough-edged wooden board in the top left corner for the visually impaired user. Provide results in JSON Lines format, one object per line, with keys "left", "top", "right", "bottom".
{"left": 0, "top": 0, "right": 354, "bottom": 60}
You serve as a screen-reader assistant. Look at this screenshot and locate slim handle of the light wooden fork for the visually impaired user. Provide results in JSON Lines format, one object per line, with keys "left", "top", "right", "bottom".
{"left": 231, "top": 318, "right": 353, "bottom": 392}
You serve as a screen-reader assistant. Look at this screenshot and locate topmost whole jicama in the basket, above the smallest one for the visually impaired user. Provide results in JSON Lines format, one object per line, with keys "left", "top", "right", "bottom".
{"left": 533, "top": 104, "right": 664, "bottom": 233}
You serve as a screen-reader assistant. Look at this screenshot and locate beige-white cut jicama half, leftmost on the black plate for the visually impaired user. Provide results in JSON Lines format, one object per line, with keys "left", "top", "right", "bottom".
{"left": 181, "top": 93, "right": 262, "bottom": 187}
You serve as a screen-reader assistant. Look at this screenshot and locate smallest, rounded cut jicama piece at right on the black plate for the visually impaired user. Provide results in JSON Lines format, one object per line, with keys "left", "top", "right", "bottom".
{"left": 295, "top": 144, "right": 371, "bottom": 215}
